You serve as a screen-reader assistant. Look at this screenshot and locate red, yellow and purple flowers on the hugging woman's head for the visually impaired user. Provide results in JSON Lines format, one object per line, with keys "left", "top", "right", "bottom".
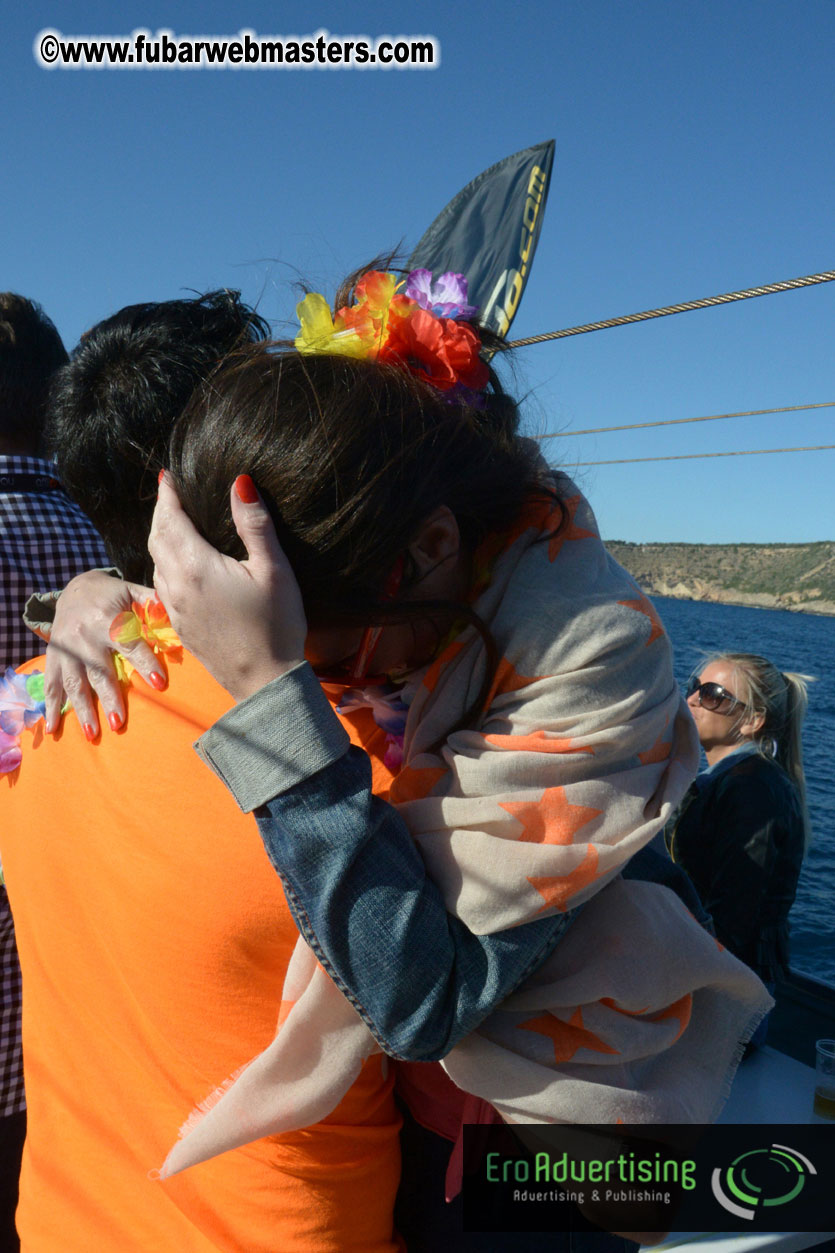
{"left": 296, "top": 269, "right": 488, "bottom": 401}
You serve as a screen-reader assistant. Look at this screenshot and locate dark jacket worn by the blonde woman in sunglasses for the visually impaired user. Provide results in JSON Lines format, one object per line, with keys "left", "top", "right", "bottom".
{"left": 667, "top": 753, "right": 804, "bottom": 981}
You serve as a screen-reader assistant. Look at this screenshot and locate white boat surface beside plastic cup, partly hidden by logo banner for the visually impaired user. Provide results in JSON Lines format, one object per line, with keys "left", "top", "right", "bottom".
{"left": 654, "top": 1045, "right": 835, "bottom": 1253}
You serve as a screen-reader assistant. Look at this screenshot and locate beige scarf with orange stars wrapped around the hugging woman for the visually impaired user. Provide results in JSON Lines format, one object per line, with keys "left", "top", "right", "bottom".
{"left": 163, "top": 479, "right": 771, "bottom": 1177}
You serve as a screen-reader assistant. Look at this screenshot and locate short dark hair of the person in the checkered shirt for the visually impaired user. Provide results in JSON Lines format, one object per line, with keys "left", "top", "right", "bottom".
{"left": 0, "top": 292, "right": 68, "bottom": 455}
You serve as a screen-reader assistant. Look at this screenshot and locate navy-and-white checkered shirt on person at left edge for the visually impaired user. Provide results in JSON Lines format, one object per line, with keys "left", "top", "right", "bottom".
{"left": 0, "top": 456, "right": 109, "bottom": 1118}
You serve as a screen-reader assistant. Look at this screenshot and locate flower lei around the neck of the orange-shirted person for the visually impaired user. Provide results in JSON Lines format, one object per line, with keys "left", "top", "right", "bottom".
{"left": 0, "top": 599, "right": 182, "bottom": 774}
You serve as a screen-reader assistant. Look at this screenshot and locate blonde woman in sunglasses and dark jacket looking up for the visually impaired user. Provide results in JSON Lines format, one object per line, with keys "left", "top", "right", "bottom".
{"left": 667, "top": 653, "right": 809, "bottom": 984}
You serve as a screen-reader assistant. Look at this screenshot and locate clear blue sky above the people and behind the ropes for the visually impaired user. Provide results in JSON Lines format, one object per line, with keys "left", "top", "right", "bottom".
{"left": 0, "top": 0, "right": 835, "bottom": 543}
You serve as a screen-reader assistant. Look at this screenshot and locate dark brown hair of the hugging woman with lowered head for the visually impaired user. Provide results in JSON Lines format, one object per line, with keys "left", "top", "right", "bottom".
{"left": 169, "top": 345, "right": 555, "bottom": 726}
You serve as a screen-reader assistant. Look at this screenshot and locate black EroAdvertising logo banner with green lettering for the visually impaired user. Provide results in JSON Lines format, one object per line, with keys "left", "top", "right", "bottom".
{"left": 463, "top": 1124, "right": 835, "bottom": 1232}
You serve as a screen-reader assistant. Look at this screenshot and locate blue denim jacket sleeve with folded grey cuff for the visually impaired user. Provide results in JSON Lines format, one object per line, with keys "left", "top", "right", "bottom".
{"left": 194, "top": 664, "right": 572, "bottom": 1061}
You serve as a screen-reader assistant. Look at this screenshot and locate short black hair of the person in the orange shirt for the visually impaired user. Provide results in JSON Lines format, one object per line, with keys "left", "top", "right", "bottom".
{"left": 46, "top": 291, "right": 268, "bottom": 583}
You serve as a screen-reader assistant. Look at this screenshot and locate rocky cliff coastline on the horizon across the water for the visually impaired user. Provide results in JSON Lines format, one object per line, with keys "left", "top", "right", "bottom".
{"left": 606, "top": 540, "right": 835, "bottom": 614}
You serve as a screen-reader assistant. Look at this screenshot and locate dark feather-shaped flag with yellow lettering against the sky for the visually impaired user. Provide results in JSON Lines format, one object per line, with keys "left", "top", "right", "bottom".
{"left": 409, "top": 139, "right": 554, "bottom": 336}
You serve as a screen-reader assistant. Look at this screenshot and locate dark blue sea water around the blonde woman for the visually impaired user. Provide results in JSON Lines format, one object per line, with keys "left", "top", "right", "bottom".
{"left": 653, "top": 596, "right": 835, "bottom": 984}
